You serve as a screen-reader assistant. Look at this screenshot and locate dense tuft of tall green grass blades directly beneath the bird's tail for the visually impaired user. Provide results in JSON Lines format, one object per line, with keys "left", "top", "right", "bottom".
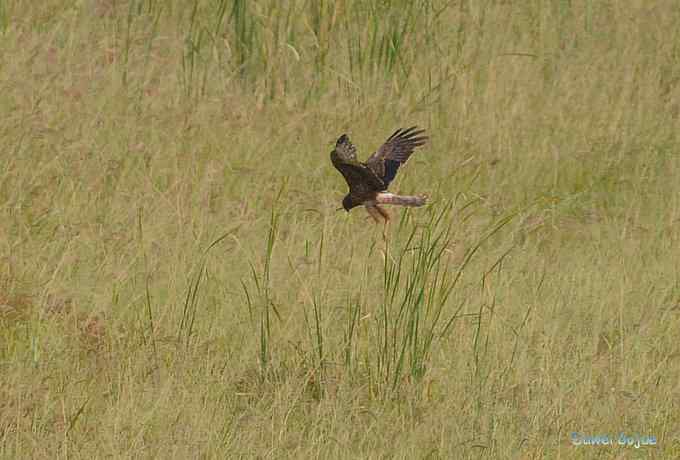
{"left": 344, "top": 202, "right": 512, "bottom": 398}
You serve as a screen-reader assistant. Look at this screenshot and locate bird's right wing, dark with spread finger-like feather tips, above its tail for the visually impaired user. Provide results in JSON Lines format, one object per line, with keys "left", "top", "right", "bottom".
{"left": 366, "top": 126, "right": 428, "bottom": 188}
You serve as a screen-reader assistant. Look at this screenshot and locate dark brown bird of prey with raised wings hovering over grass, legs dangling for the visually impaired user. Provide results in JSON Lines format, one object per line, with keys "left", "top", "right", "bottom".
{"left": 331, "top": 126, "right": 428, "bottom": 223}
